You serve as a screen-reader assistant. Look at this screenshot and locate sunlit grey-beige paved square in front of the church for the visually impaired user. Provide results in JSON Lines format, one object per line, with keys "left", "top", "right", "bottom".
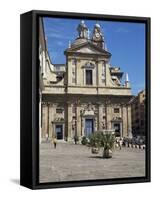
{"left": 40, "top": 143, "right": 145, "bottom": 182}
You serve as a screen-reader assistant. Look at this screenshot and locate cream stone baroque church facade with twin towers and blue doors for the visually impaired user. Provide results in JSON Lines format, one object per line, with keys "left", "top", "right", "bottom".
{"left": 39, "top": 19, "right": 132, "bottom": 141}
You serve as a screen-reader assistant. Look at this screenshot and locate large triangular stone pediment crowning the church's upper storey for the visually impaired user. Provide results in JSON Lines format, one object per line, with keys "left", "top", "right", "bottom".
{"left": 65, "top": 41, "right": 111, "bottom": 57}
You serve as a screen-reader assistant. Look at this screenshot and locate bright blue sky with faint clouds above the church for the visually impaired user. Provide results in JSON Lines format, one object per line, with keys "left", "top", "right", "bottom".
{"left": 43, "top": 17, "right": 145, "bottom": 95}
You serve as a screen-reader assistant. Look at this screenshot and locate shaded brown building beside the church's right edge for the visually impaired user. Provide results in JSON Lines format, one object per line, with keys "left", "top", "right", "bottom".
{"left": 131, "top": 90, "right": 146, "bottom": 136}
